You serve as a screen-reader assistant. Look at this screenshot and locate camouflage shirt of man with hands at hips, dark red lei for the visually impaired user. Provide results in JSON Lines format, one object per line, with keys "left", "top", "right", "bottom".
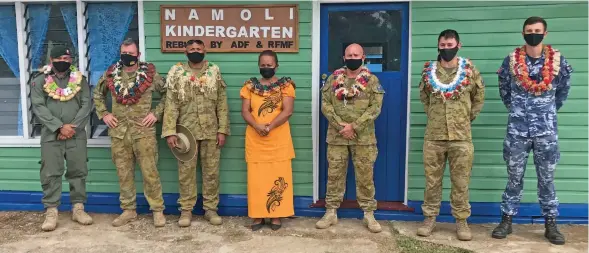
{"left": 94, "top": 62, "right": 166, "bottom": 139}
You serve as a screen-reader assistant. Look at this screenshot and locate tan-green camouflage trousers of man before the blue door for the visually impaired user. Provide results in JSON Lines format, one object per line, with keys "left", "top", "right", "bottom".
{"left": 325, "top": 145, "right": 378, "bottom": 212}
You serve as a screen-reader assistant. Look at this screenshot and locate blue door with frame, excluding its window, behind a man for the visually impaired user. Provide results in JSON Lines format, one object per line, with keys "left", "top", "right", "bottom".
{"left": 319, "top": 3, "right": 409, "bottom": 202}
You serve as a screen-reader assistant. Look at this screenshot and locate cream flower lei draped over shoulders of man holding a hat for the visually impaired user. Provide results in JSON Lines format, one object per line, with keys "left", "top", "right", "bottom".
{"left": 166, "top": 62, "right": 219, "bottom": 100}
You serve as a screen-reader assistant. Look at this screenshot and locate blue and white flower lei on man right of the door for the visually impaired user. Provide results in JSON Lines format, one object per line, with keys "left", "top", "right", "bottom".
{"left": 422, "top": 57, "right": 472, "bottom": 101}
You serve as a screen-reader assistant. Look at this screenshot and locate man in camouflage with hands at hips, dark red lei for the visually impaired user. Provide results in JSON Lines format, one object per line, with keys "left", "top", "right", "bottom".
{"left": 94, "top": 39, "right": 166, "bottom": 227}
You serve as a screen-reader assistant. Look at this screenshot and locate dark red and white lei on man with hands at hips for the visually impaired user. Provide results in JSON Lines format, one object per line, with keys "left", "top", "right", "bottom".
{"left": 106, "top": 62, "right": 155, "bottom": 105}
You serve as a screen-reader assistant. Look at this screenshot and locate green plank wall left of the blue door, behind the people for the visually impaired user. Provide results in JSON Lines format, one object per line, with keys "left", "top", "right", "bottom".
{"left": 0, "top": 2, "right": 313, "bottom": 200}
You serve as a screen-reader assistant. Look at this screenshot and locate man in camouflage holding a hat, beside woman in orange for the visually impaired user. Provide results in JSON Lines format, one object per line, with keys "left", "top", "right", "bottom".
{"left": 162, "top": 40, "right": 230, "bottom": 227}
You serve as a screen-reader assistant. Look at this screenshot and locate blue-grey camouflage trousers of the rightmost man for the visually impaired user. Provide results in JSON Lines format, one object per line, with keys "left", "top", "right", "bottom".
{"left": 501, "top": 134, "right": 560, "bottom": 217}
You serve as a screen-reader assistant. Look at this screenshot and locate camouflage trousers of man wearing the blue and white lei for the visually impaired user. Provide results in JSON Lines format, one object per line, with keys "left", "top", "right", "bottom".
{"left": 421, "top": 140, "right": 474, "bottom": 219}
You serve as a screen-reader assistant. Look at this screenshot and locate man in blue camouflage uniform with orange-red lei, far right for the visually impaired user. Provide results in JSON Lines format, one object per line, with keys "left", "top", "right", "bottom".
{"left": 492, "top": 17, "right": 573, "bottom": 245}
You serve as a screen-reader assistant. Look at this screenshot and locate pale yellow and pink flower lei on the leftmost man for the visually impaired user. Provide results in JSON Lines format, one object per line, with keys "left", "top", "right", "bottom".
{"left": 42, "top": 65, "right": 83, "bottom": 102}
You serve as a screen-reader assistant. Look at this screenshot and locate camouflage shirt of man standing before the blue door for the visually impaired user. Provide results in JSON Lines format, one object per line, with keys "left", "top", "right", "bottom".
{"left": 321, "top": 69, "right": 384, "bottom": 145}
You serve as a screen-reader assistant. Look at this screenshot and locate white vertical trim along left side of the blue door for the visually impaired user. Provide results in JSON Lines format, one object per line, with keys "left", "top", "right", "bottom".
{"left": 311, "top": 1, "right": 321, "bottom": 203}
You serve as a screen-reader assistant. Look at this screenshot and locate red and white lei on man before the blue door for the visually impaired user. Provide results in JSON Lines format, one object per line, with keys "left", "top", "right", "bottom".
{"left": 332, "top": 67, "right": 372, "bottom": 100}
